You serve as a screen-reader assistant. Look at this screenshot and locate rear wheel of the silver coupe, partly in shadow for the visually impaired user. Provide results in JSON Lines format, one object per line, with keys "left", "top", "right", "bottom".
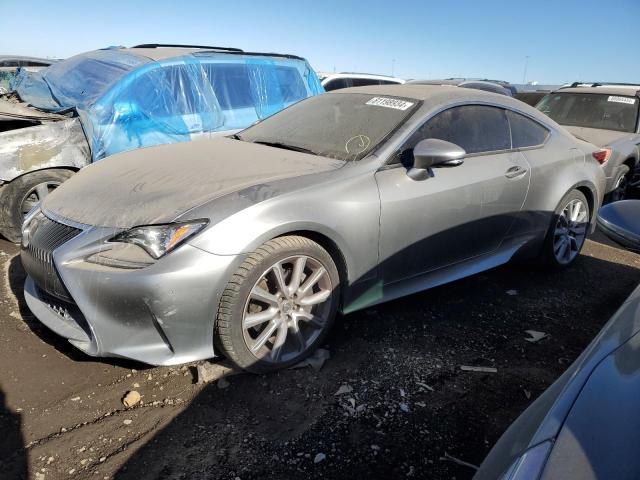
{"left": 540, "top": 190, "right": 591, "bottom": 270}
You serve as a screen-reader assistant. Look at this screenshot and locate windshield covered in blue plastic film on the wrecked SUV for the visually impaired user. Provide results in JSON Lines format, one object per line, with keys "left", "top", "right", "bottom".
{"left": 15, "top": 49, "right": 151, "bottom": 111}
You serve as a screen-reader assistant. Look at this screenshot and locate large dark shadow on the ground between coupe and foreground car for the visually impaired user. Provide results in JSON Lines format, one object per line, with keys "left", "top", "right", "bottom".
{"left": 115, "top": 248, "right": 640, "bottom": 479}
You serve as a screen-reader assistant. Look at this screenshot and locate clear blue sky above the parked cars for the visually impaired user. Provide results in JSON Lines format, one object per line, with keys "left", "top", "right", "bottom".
{"left": 0, "top": 0, "right": 640, "bottom": 83}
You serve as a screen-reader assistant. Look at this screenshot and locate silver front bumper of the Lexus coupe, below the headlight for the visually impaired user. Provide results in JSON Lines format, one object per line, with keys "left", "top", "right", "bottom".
{"left": 23, "top": 210, "right": 242, "bottom": 365}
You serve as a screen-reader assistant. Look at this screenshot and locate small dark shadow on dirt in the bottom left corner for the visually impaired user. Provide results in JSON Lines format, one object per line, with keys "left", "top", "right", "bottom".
{"left": 0, "top": 388, "right": 29, "bottom": 480}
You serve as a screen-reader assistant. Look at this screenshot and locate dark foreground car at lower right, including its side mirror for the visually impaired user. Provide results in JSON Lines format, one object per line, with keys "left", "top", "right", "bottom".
{"left": 474, "top": 200, "right": 640, "bottom": 480}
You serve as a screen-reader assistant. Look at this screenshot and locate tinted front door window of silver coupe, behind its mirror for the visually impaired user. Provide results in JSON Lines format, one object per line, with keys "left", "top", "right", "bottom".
{"left": 396, "top": 105, "right": 511, "bottom": 166}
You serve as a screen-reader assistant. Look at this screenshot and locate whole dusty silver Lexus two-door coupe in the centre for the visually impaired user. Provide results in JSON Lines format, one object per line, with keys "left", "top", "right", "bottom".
{"left": 22, "top": 85, "right": 605, "bottom": 372}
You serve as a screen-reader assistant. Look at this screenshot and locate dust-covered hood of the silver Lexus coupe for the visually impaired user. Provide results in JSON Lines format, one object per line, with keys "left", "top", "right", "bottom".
{"left": 42, "top": 138, "right": 344, "bottom": 228}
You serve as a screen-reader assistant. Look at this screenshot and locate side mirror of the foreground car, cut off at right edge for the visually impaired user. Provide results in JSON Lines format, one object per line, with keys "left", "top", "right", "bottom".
{"left": 597, "top": 200, "right": 640, "bottom": 252}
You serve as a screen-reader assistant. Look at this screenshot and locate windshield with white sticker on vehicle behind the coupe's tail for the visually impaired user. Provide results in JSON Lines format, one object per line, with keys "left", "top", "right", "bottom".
{"left": 536, "top": 93, "right": 639, "bottom": 132}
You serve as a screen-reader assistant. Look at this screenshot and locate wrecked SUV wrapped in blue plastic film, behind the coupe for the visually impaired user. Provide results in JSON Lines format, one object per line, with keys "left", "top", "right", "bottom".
{"left": 0, "top": 45, "right": 322, "bottom": 241}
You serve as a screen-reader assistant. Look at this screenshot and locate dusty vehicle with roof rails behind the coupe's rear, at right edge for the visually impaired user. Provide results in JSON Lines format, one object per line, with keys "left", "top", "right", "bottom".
{"left": 536, "top": 83, "right": 640, "bottom": 201}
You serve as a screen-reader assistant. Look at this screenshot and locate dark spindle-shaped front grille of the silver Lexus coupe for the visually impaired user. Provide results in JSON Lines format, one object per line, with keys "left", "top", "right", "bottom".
{"left": 21, "top": 213, "right": 82, "bottom": 302}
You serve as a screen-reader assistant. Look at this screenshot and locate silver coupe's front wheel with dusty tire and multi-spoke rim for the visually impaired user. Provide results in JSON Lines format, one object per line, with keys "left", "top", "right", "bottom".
{"left": 215, "top": 235, "right": 340, "bottom": 373}
